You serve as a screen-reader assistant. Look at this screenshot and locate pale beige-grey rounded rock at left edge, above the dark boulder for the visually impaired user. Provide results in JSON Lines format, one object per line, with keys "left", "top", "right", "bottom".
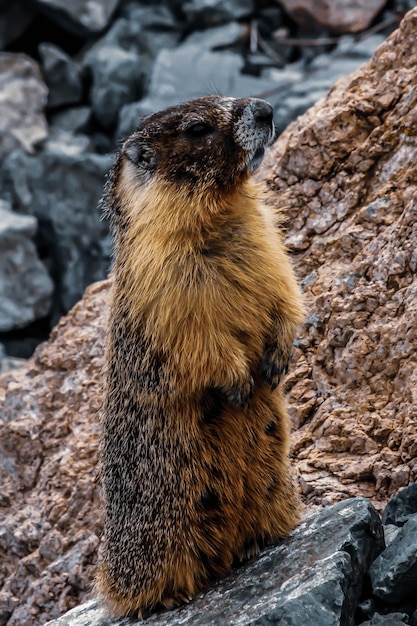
{"left": 0, "top": 52, "right": 48, "bottom": 157}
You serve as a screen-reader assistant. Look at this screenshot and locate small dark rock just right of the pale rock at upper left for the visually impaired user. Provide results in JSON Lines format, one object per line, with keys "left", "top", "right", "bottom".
{"left": 39, "top": 43, "right": 82, "bottom": 109}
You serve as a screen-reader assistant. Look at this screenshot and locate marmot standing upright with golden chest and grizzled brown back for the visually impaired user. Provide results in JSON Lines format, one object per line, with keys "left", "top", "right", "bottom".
{"left": 97, "top": 96, "right": 303, "bottom": 615}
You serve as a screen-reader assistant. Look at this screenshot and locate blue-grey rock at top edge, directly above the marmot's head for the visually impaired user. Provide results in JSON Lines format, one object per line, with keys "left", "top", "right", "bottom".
{"left": 182, "top": 0, "right": 255, "bottom": 26}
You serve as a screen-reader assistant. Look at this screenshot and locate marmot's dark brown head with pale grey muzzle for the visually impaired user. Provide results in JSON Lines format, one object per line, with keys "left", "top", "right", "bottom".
{"left": 119, "top": 96, "right": 274, "bottom": 191}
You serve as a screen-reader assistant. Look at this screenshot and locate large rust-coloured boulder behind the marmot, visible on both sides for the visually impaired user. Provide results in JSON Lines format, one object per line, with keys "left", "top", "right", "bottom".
{"left": 0, "top": 9, "right": 417, "bottom": 626}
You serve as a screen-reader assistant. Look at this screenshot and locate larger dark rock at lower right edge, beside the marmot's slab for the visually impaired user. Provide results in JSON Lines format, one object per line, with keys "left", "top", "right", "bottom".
{"left": 369, "top": 513, "right": 417, "bottom": 604}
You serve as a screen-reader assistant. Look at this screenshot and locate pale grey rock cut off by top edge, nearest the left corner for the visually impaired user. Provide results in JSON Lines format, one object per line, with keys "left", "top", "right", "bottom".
{"left": 30, "top": 0, "right": 119, "bottom": 36}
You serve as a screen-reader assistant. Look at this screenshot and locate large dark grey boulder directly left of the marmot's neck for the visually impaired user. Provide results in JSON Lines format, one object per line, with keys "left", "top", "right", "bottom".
{"left": 0, "top": 141, "right": 112, "bottom": 320}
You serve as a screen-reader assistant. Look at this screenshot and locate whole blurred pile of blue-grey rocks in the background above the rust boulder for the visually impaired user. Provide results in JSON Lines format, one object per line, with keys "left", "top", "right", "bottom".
{"left": 0, "top": 0, "right": 416, "bottom": 369}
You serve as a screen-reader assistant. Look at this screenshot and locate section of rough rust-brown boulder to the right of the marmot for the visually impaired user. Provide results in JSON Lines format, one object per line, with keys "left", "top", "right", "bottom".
{"left": 267, "top": 10, "right": 417, "bottom": 502}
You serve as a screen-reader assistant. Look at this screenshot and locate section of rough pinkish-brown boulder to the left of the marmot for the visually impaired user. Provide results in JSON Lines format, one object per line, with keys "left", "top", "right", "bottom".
{"left": 0, "top": 283, "right": 107, "bottom": 626}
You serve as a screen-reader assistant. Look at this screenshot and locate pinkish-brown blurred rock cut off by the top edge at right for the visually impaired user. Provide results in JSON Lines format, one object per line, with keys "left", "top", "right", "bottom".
{"left": 278, "top": 0, "right": 385, "bottom": 33}
